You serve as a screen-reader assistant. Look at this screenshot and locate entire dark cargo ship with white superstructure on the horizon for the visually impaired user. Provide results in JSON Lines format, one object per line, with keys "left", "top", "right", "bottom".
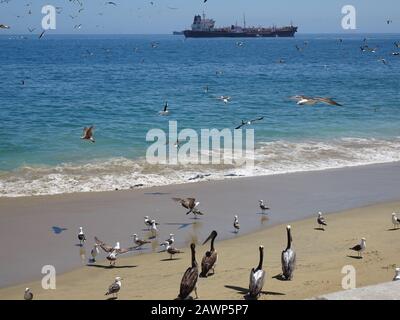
{"left": 183, "top": 13, "right": 297, "bottom": 38}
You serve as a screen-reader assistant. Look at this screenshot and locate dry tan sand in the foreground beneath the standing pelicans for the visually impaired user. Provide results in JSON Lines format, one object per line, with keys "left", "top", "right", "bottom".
{"left": 0, "top": 202, "right": 400, "bottom": 300}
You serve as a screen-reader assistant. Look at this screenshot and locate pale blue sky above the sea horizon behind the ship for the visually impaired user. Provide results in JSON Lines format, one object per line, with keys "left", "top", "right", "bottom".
{"left": 0, "top": 0, "right": 400, "bottom": 35}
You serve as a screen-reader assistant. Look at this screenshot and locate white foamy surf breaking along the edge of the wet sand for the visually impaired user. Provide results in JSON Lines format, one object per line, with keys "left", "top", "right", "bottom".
{"left": 0, "top": 138, "right": 400, "bottom": 197}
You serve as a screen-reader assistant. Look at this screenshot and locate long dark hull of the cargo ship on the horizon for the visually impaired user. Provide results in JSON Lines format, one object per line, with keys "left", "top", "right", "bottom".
{"left": 183, "top": 28, "right": 297, "bottom": 38}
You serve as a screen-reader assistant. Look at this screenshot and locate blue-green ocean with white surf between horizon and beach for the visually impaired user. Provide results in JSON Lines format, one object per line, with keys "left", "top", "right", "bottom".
{"left": 0, "top": 34, "right": 400, "bottom": 197}
